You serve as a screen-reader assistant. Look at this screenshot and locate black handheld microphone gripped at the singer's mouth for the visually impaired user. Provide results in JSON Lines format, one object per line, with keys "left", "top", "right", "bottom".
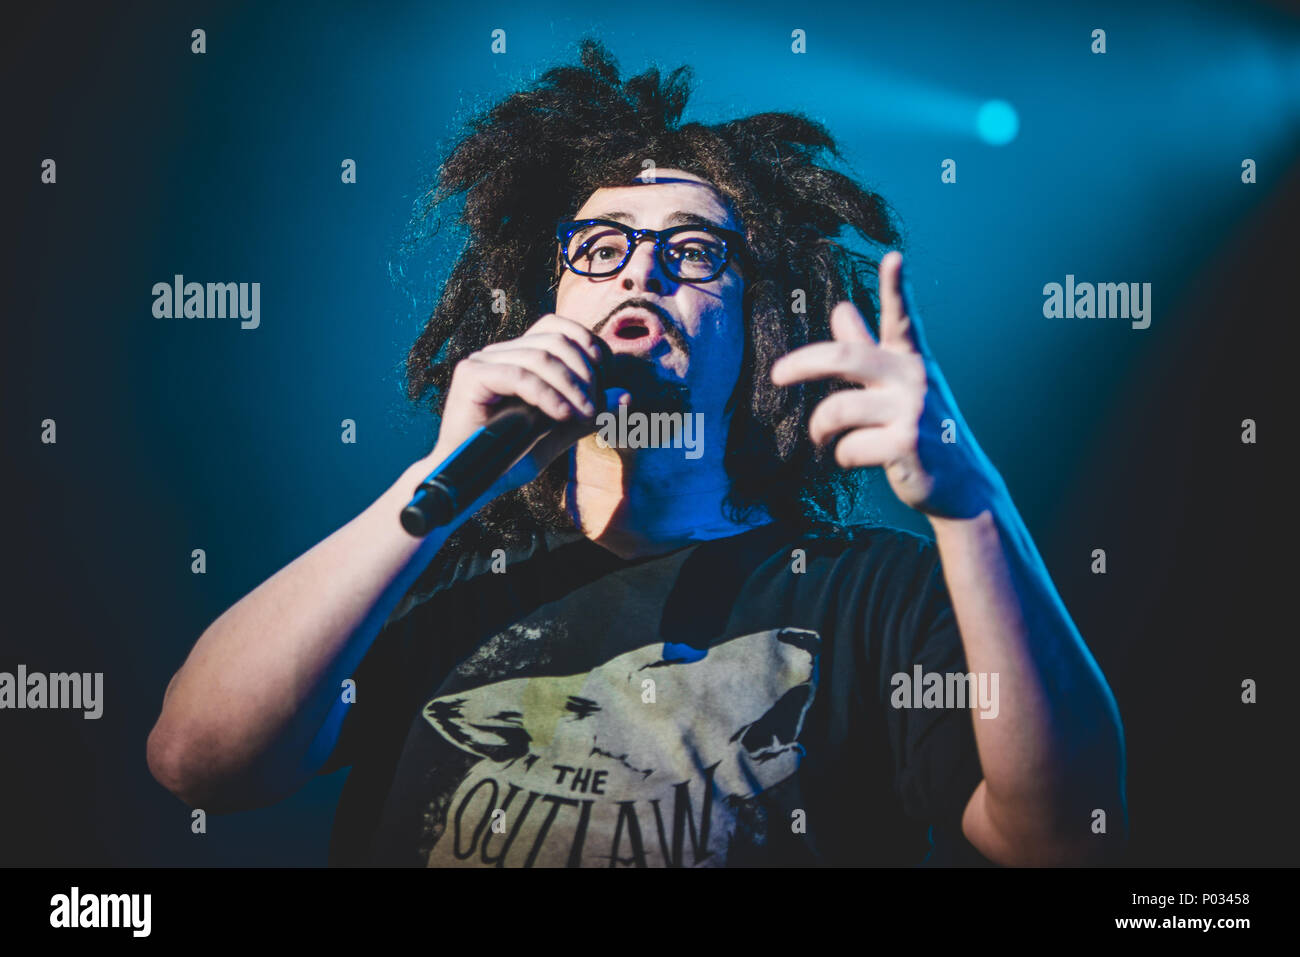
{"left": 400, "top": 337, "right": 612, "bottom": 538}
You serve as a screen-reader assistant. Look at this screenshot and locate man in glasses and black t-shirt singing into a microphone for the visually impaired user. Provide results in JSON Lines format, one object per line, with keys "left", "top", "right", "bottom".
{"left": 148, "top": 40, "right": 1127, "bottom": 867}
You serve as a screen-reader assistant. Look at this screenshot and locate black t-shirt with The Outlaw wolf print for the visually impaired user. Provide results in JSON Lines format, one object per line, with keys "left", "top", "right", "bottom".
{"left": 320, "top": 523, "right": 987, "bottom": 867}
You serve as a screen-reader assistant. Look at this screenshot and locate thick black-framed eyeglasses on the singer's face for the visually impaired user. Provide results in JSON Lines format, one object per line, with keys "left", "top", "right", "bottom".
{"left": 555, "top": 220, "right": 749, "bottom": 282}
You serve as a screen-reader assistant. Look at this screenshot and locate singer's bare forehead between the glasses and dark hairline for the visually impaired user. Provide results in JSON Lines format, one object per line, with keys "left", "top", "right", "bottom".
{"left": 573, "top": 169, "right": 737, "bottom": 229}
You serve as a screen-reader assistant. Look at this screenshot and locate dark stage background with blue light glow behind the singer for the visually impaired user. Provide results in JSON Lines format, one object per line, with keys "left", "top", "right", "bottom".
{"left": 0, "top": 3, "right": 1300, "bottom": 866}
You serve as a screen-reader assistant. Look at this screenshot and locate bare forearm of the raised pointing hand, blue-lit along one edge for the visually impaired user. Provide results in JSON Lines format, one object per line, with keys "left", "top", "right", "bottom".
{"left": 932, "top": 495, "right": 1127, "bottom": 862}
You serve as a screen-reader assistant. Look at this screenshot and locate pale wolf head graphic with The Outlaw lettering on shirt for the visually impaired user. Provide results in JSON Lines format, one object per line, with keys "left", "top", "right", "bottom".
{"left": 423, "top": 628, "right": 820, "bottom": 867}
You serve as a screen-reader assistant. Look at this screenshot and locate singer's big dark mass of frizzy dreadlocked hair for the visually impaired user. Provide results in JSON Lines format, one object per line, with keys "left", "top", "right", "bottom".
{"left": 406, "top": 38, "right": 901, "bottom": 561}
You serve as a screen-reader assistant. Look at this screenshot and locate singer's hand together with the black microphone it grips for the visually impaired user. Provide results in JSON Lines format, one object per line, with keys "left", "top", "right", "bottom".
{"left": 402, "top": 313, "right": 627, "bottom": 536}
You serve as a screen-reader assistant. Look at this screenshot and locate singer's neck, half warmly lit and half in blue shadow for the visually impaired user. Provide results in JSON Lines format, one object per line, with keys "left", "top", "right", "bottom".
{"left": 564, "top": 436, "right": 771, "bottom": 558}
